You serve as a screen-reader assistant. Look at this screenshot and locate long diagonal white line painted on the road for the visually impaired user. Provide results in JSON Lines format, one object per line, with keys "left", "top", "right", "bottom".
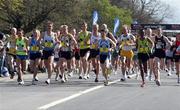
{"left": 38, "top": 79, "right": 119, "bottom": 110}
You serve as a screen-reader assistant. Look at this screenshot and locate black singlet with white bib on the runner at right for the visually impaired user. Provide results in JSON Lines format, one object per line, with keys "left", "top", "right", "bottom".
{"left": 155, "top": 36, "right": 166, "bottom": 50}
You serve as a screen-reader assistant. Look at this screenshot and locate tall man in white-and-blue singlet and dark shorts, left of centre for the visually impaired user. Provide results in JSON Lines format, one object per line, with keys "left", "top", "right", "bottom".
{"left": 41, "top": 21, "right": 56, "bottom": 84}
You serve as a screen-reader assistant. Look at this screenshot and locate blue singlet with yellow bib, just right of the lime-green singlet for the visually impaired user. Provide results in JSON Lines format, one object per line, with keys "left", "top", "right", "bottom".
{"left": 29, "top": 38, "right": 40, "bottom": 53}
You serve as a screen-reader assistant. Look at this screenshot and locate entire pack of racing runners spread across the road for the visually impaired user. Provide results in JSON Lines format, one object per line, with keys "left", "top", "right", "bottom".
{"left": 0, "top": 21, "right": 180, "bottom": 87}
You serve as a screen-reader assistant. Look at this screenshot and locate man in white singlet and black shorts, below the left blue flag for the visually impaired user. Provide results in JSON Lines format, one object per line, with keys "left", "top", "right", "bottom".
{"left": 89, "top": 24, "right": 101, "bottom": 82}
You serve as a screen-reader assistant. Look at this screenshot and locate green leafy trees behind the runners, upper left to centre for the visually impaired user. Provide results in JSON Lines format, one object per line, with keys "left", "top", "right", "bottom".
{"left": 0, "top": 0, "right": 132, "bottom": 33}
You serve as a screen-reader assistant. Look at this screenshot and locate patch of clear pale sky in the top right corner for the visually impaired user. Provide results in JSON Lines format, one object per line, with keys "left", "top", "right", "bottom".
{"left": 161, "top": 0, "right": 180, "bottom": 24}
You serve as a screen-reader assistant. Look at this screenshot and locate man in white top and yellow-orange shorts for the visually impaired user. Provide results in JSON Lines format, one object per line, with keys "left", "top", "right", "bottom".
{"left": 118, "top": 25, "right": 135, "bottom": 81}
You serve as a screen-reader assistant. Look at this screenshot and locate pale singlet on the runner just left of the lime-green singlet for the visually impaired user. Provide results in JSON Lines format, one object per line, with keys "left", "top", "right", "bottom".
{"left": 8, "top": 36, "right": 16, "bottom": 55}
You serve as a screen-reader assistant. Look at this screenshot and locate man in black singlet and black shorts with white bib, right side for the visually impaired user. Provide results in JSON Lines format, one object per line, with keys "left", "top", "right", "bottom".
{"left": 153, "top": 28, "right": 170, "bottom": 86}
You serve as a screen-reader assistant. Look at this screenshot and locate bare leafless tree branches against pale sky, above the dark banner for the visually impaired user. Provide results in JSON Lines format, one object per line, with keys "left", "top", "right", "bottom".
{"left": 110, "top": 0, "right": 172, "bottom": 23}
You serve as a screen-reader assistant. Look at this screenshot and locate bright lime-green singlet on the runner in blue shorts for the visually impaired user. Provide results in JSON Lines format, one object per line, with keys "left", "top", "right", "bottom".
{"left": 16, "top": 38, "right": 27, "bottom": 55}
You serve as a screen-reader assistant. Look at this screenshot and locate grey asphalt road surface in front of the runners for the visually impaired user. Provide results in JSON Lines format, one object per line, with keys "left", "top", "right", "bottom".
{"left": 0, "top": 72, "right": 180, "bottom": 110}
